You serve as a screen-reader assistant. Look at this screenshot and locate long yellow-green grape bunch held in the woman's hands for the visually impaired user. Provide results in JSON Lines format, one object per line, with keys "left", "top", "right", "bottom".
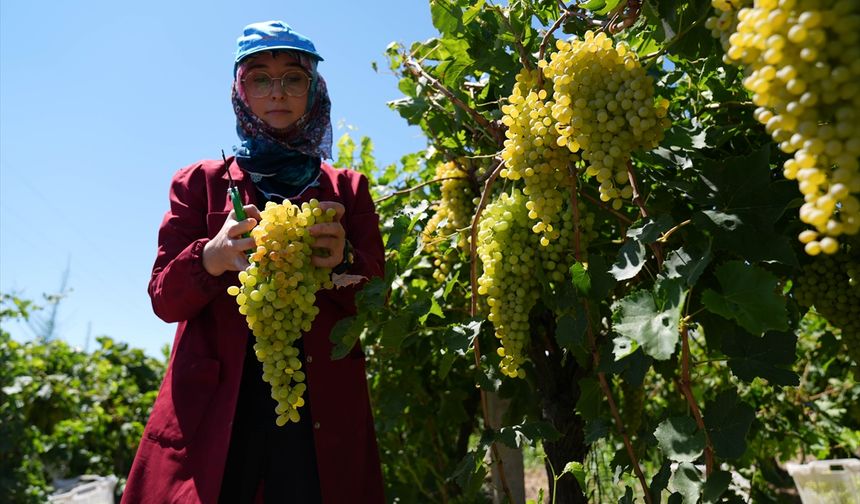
{"left": 227, "top": 200, "right": 336, "bottom": 426}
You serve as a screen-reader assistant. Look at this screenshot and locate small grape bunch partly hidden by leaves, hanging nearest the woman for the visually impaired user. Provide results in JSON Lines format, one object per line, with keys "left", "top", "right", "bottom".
{"left": 423, "top": 161, "right": 475, "bottom": 282}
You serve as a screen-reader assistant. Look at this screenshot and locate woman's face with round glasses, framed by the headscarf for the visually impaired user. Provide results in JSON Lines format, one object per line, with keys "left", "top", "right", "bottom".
{"left": 241, "top": 51, "right": 308, "bottom": 129}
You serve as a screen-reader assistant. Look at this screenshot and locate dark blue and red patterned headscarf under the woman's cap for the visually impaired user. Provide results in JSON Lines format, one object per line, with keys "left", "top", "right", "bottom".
{"left": 232, "top": 51, "right": 332, "bottom": 197}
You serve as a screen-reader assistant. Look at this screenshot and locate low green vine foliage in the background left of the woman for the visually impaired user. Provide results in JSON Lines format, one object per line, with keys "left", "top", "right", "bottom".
{"left": 0, "top": 294, "right": 165, "bottom": 503}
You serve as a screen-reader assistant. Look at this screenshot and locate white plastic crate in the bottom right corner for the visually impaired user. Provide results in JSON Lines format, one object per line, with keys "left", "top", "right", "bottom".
{"left": 785, "top": 459, "right": 860, "bottom": 504}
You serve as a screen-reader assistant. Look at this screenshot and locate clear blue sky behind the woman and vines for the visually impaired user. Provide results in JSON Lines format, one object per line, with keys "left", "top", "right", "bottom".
{"left": 0, "top": 0, "right": 435, "bottom": 355}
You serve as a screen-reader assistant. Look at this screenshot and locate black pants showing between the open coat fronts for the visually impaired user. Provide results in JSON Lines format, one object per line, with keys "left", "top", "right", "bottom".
{"left": 219, "top": 334, "right": 322, "bottom": 504}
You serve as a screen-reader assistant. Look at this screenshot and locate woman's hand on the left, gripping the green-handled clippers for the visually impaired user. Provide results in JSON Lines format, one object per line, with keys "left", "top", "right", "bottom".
{"left": 203, "top": 205, "right": 260, "bottom": 276}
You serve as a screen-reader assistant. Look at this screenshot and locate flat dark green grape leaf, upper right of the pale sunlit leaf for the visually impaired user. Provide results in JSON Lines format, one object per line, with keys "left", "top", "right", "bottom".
{"left": 702, "top": 261, "right": 788, "bottom": 335}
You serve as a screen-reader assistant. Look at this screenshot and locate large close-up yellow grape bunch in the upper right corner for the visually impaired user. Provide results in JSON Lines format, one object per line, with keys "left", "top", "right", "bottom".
{"left": 726, "top": 0, "right": 860, "bottom": 255}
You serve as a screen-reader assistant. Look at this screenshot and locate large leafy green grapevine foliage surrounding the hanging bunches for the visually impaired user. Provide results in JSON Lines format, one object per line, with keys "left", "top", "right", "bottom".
{"left": 340, "top": 0, "right": 860, "bottom": 502}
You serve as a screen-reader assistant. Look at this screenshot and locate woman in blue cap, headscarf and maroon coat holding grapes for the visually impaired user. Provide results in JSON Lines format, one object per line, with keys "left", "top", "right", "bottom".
{"left": 123, "top": 21, "right": 384, "bottom": 503}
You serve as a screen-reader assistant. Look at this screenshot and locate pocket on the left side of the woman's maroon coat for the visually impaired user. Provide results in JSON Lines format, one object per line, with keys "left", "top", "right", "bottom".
{"left": 148, "top": 353, "right": 221, "bottom": 448}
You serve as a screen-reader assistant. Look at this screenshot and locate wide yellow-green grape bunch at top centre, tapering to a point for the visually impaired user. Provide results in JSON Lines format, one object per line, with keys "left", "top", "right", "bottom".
{"left": 540, "top": 31, "right": 669, "bottom": 209}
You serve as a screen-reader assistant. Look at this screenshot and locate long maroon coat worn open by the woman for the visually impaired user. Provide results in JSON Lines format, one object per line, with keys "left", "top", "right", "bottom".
{"left": 122, "top": 159, "right": 384, "bottom": 504}
